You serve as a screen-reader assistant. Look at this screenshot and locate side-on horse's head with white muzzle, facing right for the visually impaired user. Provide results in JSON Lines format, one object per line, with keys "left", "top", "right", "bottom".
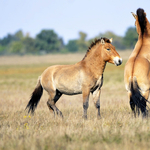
{"left": 101, "top": 38, "right": 122, "bottom": 66}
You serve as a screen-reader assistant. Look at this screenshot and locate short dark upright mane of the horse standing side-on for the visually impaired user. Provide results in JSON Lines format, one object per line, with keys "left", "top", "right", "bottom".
{"left": 83, "top": 37, "right": 111, "bottom": 60}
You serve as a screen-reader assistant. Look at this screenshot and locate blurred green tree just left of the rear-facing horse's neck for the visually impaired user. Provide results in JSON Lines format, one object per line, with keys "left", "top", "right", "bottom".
{"left": 123, "top": 27, "right": 138, "bottom": 49}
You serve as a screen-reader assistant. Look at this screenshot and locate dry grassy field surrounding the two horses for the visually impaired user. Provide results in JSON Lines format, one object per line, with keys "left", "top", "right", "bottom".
{"left": 0, "top": 51, "right": 150, "bottom": 150}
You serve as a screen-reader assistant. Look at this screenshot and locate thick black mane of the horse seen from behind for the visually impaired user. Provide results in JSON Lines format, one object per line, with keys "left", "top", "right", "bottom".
{"left": 136, "top": 8, "right": 147, "bottom": 35}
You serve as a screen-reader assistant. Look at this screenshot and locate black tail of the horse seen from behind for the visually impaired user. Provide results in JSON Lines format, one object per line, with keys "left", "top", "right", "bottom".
{"left": 130, "top": 76, "right": 147, "bottom": 116}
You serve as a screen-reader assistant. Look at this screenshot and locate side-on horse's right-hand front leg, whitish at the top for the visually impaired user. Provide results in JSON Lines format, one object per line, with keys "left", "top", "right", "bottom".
{"left": 92, "top": 88, "right": 101, "bottom": 119}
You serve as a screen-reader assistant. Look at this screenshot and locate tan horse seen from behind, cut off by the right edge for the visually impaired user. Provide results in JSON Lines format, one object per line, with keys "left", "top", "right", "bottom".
{"left": 124, "top": 8, "right": 150, "bottom": 117}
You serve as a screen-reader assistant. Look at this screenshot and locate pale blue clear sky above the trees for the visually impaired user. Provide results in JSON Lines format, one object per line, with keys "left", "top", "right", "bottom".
{"left": 0, "top": 0, "right": 150, "bottom": 43}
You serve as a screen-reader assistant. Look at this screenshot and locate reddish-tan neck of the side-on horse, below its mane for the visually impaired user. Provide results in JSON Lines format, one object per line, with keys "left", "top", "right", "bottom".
{"left": 82, "top": 49, "right": 106, "bottom": 77}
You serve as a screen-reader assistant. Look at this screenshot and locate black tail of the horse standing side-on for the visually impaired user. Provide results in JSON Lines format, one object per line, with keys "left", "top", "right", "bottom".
{"left": 26, "top": 77, "right": 43, "bottom": 113}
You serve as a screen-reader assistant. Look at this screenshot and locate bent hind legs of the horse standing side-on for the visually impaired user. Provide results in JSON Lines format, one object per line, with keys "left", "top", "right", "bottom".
{"left": 47, "top": 90, "right": 63, "bottom": 117}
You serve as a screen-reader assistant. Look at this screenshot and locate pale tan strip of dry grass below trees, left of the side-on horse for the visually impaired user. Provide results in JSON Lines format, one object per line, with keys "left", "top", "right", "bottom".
{"left": 0, "top": 53, "right": 85, "bottom": 65}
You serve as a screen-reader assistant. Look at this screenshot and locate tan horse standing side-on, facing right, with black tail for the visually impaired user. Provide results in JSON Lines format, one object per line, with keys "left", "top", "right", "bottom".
{"left": 26, "top": 38, "right": 122, "bottom": 119}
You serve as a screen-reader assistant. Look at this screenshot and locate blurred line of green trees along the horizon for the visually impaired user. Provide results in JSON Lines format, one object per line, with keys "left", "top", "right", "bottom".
{"left": 0, "top": 27, "right": 138, "bottom": 55}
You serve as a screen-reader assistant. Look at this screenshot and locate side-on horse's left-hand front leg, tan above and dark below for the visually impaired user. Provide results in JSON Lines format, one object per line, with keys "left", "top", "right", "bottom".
{"left": 82, "top": 89, "right": 90, "bottom": 119}
